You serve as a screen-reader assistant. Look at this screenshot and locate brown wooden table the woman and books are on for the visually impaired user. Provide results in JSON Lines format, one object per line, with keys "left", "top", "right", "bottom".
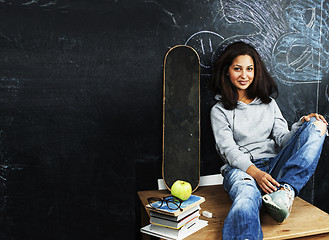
{"left": 138, "top": 185, "right": 329, "bottom": 240}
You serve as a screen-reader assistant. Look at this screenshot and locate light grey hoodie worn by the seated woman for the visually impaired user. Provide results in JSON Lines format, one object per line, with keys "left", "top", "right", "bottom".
{"left": 210, "top": 96, "right": 302, "bottom": 171}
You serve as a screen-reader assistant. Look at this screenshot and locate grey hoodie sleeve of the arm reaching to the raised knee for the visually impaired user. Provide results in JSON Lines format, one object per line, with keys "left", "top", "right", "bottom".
{"left": 272, "top": 99, "right": 302, "bottom": 148}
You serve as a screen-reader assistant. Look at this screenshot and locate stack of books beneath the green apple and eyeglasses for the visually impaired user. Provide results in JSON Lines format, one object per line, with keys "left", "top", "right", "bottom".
{"left": 141, "top": 195, "right": 208, "bottom": 240}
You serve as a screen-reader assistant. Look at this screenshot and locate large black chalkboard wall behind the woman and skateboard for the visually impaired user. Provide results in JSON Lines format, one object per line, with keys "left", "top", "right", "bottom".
{"left": 0, "top": 0, "right": 329, "bottom": 239}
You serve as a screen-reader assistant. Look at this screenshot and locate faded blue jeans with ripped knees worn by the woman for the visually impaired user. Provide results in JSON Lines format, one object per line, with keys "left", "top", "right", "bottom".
{"left": 222, "top": 118, "right": 325, "bottom": 240}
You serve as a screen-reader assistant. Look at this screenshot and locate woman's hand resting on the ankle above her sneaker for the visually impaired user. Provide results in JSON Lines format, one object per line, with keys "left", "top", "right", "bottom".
{"left": 247, "top": 165, "right": 280, "bottom": 193}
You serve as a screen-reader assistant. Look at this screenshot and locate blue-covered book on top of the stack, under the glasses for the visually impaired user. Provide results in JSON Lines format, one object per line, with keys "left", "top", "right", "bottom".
{"left": 146, "top": 195, "right": 205, "bottom": 216}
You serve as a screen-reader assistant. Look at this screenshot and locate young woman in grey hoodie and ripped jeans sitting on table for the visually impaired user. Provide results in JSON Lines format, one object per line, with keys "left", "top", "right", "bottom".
{"left": 211, "top": 42, "right": 328, "bottom": 240}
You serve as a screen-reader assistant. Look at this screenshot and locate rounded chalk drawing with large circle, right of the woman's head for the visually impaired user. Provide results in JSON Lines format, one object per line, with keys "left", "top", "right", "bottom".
{"left": 272, "top": 0, "right": 323, "bottom": 84}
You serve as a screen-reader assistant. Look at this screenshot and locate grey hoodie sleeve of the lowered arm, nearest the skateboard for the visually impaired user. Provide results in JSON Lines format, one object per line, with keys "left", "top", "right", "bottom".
{"left": 210, "top": 104, "right": 253, "bottom": 172}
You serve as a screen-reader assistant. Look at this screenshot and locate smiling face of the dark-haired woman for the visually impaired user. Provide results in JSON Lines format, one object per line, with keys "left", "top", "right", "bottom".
{"left": 227, "top": 55, "right": 254, "bottom": 94}
